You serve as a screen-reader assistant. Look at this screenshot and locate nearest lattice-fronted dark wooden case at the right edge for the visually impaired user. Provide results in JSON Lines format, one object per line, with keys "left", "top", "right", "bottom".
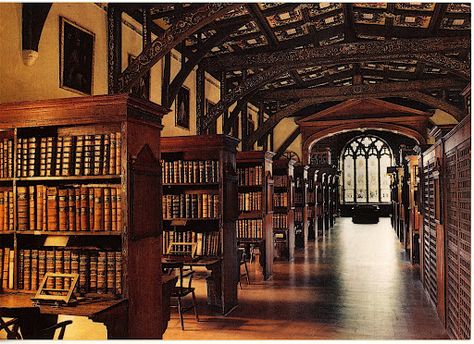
{"left": 443, "top": 115, "right": 472, "bottom": 339}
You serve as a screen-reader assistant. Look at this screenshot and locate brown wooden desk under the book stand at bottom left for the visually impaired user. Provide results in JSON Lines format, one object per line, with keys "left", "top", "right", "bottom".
{"left": 0, "top": 292, "right": 128, "bottom": 339}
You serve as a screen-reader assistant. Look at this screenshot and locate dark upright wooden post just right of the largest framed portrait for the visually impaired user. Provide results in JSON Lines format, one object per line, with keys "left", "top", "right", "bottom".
{"left": 107, "top": 4, "right": 122, "bottom": 94}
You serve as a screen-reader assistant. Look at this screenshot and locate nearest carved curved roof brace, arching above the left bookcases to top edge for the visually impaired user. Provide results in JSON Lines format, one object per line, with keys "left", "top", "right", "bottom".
{"left": 116, "top": 3, "right": 239, "bottom": 92}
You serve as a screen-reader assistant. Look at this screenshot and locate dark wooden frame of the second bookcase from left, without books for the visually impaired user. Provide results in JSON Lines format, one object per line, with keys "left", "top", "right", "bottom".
{"left": 161, "top": 135, "right": 238, "bottom": 314}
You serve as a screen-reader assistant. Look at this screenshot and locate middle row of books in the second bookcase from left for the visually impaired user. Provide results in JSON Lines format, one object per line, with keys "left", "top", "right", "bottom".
{"left": 162, "top": 194, "right": 219, "bottom": 219}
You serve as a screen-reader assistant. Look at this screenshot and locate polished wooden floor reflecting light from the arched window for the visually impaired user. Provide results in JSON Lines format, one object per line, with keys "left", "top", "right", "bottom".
{"left": 164, "top": 218, "right": 448, "bottom": 339}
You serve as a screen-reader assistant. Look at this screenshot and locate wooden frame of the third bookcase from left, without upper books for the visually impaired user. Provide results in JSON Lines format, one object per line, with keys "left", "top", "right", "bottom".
{"left": 237, "top": 151, "right": 275, "bottom": 279}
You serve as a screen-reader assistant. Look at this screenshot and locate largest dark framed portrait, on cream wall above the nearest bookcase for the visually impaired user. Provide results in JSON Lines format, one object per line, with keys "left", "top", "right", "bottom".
{"left": 59, "top": 17, "right": 95, "bottom": 95}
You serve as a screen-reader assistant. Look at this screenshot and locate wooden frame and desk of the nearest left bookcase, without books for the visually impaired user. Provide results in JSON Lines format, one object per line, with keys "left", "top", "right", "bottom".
{"left": 0, "top": 95, "right": 168, "bottom": 339}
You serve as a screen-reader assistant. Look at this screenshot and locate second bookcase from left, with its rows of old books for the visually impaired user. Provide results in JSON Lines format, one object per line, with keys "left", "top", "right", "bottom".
{"left": 161, "top": 135, "right": 239, "bottom": 314}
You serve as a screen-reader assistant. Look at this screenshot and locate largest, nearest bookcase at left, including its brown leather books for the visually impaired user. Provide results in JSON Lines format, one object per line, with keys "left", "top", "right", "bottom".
{"left": 0, "top": 95, "right": 167, "bottom": 338}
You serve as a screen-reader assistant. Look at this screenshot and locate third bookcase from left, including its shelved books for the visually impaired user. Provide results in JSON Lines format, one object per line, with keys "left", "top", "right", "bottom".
{"left": 237, "top": 151, "right": 275, "bottom": 279}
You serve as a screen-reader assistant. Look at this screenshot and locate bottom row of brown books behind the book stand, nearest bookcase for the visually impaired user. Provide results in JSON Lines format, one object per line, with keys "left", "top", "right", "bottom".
{"left": 18, "top": 249, "right": 122, "bottom": 294}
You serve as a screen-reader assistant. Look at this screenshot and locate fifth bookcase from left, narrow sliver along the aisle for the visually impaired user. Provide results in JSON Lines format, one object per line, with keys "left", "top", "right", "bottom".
{"left": 294, "top": 164, "right": 309, "bottom": 248}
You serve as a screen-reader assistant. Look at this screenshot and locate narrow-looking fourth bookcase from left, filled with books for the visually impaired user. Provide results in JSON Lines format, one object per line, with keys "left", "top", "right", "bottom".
{"left": 273, "top": 159, "right": 295, "bottom": 260}
